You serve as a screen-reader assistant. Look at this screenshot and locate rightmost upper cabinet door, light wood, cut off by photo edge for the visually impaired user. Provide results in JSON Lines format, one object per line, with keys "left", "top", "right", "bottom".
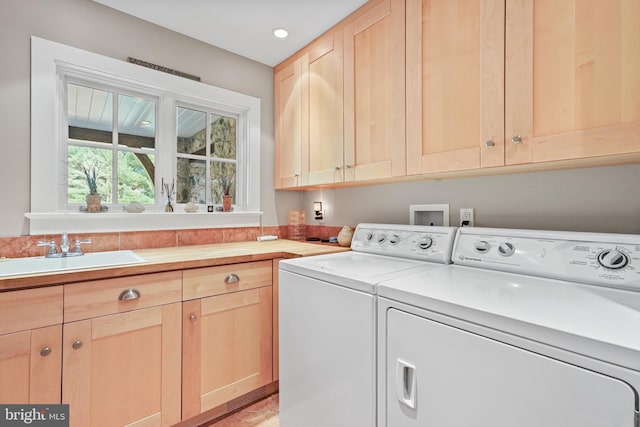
{"left": 505, "top": 0, "right": 640, "bottom": 164}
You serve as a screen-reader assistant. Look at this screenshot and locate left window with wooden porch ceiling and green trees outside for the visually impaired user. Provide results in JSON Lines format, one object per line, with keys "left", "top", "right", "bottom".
{"left": 66, "top": 81, "right": 157, "bottom": 209}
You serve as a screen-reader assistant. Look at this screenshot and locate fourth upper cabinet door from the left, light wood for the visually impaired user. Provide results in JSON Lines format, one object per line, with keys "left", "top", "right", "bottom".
{"left": 406, "top": 0, "right": 505, "bottom": 175}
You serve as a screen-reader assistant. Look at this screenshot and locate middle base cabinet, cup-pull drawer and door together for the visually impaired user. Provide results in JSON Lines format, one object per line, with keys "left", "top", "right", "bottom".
{"left": 62, "top": 272, "right": 182, "bottom": 427}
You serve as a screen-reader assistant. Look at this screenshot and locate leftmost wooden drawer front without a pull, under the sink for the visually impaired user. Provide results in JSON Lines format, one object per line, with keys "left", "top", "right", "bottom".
{"left": 0, "top": 286, "right": 62, "bottom": 335}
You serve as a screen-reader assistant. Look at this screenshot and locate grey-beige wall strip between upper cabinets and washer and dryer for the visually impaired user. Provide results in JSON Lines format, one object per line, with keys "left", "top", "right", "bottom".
{"left": 303, "top": 165, "right": 640, "bottom": 234}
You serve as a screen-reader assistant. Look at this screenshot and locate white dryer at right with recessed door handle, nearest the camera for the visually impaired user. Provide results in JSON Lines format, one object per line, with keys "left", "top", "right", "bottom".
{"left": 378, "top": 228, "right": 640, "bottom": 427}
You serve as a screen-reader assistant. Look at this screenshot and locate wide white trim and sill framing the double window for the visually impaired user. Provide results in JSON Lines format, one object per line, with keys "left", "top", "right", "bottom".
{"left": 25, "top": 37, "right": 260, "bottom": 234}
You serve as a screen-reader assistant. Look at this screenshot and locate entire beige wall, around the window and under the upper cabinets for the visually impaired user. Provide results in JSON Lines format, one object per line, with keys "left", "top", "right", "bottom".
{"left": 0, "top": 0, "right": 640, "bottom": 236}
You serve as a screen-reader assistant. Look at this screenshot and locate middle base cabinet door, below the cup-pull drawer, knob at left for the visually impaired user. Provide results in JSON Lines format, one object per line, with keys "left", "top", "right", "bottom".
{"left": 62, "top": 303, "right": 181, "bottom": 427}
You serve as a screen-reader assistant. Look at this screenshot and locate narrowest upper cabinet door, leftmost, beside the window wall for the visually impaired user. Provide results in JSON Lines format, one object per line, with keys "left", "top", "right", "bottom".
{"left": 274, "top": 58, "right": 308, "bottom": 188}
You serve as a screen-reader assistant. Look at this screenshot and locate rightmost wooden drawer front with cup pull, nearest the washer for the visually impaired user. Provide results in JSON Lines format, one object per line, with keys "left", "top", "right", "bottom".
{"left": 183, "top": 260, "right": 272, "bottom": 301}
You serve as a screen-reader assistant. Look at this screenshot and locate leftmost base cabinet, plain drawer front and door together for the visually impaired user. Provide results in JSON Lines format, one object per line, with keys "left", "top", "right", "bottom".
{"left": 0, "top": 286, "right": 62, "bottom": 404}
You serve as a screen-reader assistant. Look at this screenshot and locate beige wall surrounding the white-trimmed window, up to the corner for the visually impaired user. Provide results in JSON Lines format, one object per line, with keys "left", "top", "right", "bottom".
{"left": 0, "top": 0, "right": 301, "bottom": 236}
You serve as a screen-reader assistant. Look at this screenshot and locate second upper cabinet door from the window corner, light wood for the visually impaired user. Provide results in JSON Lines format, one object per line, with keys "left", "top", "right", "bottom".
{"left": 302, "top": 31, "right": 344, "bottom": 185}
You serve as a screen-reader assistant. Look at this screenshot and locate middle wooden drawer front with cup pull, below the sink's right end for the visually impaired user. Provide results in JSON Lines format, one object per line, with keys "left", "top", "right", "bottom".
{"left": 64, "top": 271, "right": 182, "bottom": 322}
